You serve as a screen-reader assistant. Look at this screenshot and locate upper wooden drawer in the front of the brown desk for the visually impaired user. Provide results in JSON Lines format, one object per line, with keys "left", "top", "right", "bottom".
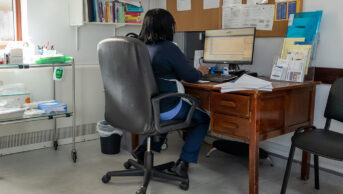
{"left": 211, "top": 93, "right": 250, "bottom": 118}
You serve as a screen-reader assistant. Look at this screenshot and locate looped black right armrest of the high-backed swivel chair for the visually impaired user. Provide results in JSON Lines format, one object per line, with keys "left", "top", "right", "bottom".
{"left": 152, "top": 93, "right": 200, "bottom": 134}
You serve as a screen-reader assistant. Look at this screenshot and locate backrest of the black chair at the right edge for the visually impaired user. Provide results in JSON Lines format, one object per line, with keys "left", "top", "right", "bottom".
{"left": 324, "top": 78, "right": 343, "bottom": 122}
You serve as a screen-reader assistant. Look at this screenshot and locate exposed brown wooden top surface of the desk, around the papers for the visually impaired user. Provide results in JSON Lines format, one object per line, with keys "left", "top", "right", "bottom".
{"left": 183, "top": 78, "right": 321, "bottom": 94}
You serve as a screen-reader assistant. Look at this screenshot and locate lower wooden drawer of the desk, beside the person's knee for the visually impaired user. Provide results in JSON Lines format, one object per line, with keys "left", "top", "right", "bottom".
{"left": 211, "top": 113, "right": 250, "bottom": 140}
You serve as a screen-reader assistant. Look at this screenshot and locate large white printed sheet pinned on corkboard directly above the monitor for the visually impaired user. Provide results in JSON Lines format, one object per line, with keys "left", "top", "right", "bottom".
{"left": 222, "top": 5, "right": 275, "bottom": 30}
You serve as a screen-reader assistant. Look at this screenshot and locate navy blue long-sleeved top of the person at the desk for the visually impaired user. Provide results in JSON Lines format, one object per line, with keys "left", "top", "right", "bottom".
{"left": 147, "top": 40, "right": 202, "bottom": 113}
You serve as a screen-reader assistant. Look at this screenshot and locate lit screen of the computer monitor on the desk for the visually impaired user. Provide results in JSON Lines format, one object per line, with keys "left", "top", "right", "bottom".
{"left": 204, "top": 28, "right": 256, "bottom": 64}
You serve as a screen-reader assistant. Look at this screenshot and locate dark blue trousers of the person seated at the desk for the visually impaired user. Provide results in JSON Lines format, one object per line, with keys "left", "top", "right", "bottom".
{"left": 143, "top": 101, "right": 210, "bottom": 163}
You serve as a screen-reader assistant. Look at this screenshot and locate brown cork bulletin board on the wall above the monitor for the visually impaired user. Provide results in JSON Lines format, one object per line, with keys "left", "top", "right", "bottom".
{"left": 167, "top": 0, "right": 303, "bottom": 37}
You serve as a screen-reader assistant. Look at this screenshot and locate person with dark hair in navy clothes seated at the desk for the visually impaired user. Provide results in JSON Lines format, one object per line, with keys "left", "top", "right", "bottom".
{"left": 132, "top": 9, "right": 210, "bottom": 176}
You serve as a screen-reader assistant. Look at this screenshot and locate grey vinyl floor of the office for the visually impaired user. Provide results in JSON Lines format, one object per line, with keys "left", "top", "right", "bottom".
{"left": 0, "top": 134, "right": 343, "bottom": 194}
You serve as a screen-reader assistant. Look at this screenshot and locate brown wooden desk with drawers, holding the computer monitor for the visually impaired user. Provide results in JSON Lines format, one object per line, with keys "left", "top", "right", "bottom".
{"left": 184, "top": 81, "right": 320, "bottom": 194}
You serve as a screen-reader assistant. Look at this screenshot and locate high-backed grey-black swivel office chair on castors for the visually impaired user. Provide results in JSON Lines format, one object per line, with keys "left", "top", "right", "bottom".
{"left": 98, "top": 37, "right": 199, "bottom": 194}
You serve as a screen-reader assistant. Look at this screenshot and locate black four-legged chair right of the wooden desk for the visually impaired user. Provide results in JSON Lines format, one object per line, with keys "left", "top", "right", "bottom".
{"left": 281, "top": 78, "right": 343, "bottom": 194}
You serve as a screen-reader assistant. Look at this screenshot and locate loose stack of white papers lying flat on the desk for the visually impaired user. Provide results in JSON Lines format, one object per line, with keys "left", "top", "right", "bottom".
{"left": 214, "top": 74, "right": 273, "bottom": 93}
